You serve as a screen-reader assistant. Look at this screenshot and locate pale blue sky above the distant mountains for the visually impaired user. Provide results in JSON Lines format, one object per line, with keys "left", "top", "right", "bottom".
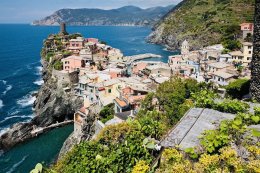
{"left": 0, "top": 0, "right": 181, "bottom": 23}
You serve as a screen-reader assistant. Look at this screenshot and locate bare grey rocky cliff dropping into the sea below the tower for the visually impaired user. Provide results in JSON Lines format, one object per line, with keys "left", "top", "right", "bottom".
{"left": 0, "top": 33, "right": 83, "bottom": 150}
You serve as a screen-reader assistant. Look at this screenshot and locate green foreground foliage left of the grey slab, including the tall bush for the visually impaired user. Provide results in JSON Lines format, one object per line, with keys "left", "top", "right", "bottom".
{"left": 46, "top": 78, "right": 200, "bottom": 173}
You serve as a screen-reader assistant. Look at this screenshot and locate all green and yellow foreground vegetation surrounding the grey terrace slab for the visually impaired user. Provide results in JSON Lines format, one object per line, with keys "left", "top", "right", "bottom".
{"left": 47, "top": 77, "right": 260, "bottom": 173}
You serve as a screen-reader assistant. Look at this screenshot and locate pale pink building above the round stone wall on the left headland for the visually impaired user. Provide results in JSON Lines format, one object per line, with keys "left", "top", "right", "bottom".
{"left": 61, "top": 55, "right": 85, "bottom": 73}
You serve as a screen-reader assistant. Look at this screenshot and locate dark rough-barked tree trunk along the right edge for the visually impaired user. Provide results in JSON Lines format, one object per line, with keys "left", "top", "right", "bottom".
{"left": 250, "top": 0, "right": 260, "bottom": 102}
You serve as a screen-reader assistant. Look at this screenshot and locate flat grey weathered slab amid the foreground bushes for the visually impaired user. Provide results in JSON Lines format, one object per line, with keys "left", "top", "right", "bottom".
{"left": 161, "top": 108, "right": 235, "bottom": 149}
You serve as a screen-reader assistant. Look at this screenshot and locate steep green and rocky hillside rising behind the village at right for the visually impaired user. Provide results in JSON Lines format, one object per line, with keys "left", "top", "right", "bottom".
{"left": 149, "top": 0, "right": 254, "bottom": 49}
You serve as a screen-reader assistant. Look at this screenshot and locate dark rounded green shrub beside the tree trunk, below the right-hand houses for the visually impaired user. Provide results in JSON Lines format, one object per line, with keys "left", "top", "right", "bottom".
{"left": 226, "top": 79, "right": 250, "bottom": 99}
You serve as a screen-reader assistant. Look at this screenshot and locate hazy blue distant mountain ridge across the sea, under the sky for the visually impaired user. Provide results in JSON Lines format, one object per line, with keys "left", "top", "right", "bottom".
{"left": 32, "top": 5, "right": 174, "bottom": 26}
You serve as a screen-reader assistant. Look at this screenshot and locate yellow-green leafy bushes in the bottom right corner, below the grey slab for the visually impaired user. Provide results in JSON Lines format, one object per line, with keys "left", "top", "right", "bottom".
{"left": 157, "top": 105, "right": 260, "bottom": 173}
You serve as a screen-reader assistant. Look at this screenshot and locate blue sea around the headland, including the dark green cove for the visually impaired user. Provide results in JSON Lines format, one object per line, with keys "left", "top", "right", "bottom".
{"left": 0, "top": 24, "right": 173, "bottom": 173}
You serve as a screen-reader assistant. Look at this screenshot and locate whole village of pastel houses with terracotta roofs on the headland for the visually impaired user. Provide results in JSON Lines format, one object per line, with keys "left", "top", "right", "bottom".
{"left": 40, "top": 23, "right": 253, "bottom": 141}
